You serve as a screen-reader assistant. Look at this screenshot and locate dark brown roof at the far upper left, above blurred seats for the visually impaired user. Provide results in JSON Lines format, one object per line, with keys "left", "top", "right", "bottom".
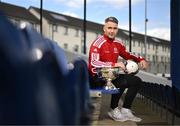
{"left": 0, "top": 2, "right": 39, "bottom": 23}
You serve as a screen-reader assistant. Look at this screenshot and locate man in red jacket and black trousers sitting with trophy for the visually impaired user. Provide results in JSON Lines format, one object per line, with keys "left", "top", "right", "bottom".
{"left": 89, "top": 17, "right": 148, "bottom": 122}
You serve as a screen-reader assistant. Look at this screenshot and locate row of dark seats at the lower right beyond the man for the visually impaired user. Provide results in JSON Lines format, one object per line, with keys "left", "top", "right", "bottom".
{"left": 139, "top": 82, "right": 180, "bottom": 124}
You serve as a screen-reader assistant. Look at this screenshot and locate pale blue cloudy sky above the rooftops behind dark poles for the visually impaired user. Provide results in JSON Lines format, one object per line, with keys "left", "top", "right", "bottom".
{"left": 0, "top": 0, "right": 170, "bottom": 40}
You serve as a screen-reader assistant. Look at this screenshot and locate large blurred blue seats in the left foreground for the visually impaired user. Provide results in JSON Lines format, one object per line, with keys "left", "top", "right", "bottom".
{"left": 0, "top": 13, "right": 91, "bottom": 125}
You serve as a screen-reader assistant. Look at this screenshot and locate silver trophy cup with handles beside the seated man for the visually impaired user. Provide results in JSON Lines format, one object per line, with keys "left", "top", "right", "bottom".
{"left": 96, "top": 67, "right": 121, "bottom": 90}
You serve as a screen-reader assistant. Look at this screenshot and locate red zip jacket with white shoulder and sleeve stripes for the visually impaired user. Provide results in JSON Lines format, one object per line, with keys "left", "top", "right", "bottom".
{"left": 89, "top": 35, "right": 144, "bottom": 76}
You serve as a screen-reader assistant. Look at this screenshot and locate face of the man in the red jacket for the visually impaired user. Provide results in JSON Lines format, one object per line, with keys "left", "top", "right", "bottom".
{"left": 103, "top": 21, "right": 118, "bottom": 39}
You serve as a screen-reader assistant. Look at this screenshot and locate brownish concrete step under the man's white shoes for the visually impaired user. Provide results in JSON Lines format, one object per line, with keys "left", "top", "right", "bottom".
{"left": 92, "top": 94, "right": 168, "bottom": 126}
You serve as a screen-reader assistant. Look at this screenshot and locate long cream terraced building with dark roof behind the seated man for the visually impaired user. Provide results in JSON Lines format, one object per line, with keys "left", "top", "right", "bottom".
{"left": 0, "top": 1, "right": 170, "bottom": 74}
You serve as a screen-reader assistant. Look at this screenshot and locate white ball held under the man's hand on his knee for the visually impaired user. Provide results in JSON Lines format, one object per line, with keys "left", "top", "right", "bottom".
{"left": 126, "top": 60, "right": 139, "bottom": 74}
